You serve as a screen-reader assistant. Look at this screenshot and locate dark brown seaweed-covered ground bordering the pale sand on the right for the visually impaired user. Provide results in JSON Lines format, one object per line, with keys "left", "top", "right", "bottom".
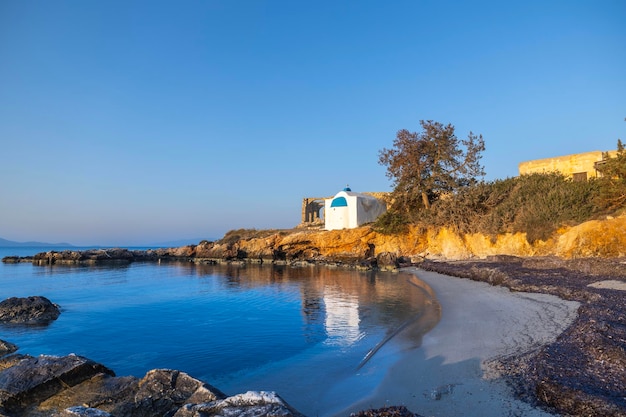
{"left": 419, "top": 256, "right": 626, "bottom": 416}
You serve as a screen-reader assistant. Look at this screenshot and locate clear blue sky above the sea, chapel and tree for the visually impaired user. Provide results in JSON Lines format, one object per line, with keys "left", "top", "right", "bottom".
{"left": 0, "top": 0, "right": 626, "bottom": 245}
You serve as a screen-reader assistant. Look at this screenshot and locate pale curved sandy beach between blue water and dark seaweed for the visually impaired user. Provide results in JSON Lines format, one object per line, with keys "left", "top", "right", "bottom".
{"left": 337, "top": 268, "right": 579, "bottom": 417}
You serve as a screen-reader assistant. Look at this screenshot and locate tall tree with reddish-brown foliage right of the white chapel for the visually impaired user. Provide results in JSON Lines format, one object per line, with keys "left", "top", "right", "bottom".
{"left": 378, "top": 120, "right": 485, "bottom": 212}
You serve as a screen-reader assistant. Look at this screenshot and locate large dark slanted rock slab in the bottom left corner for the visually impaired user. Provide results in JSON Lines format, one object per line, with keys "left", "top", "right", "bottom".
{"left": 0, "top": 355, "right": 114, "bottom": 413}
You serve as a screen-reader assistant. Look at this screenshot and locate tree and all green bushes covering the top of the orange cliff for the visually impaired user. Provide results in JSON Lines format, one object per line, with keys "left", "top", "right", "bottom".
{"left": 374, "top": 122, "right": 626, "bottom": 243}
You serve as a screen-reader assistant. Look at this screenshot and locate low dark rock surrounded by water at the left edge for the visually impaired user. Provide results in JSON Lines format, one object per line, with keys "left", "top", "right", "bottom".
{"left": 0, "top": 296, "right": 61, "bottom": 324}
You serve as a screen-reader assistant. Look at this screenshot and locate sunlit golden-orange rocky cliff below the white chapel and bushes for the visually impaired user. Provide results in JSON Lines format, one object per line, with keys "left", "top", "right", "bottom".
{"left": 193, "top": 216, "right": 626, "bottom": 263}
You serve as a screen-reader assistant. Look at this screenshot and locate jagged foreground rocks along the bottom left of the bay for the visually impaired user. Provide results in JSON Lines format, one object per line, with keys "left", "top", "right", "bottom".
{"left": 0, "top": 345, "right": 301, "bottom": 417}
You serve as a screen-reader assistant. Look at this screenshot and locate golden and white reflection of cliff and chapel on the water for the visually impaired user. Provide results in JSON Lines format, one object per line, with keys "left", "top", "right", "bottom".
{"left": 186, "top": 264, "right": 441, "bottom": 359}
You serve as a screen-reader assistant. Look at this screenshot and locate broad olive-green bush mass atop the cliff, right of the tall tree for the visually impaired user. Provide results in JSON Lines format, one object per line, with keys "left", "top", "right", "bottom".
{"left": 392, "top": 173, "right": 601, "bottom": 242}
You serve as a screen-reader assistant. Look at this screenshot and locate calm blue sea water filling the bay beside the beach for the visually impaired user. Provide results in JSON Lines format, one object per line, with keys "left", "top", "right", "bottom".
{"left": 0, "top": 247, "right": 438, "bottom": 415}
